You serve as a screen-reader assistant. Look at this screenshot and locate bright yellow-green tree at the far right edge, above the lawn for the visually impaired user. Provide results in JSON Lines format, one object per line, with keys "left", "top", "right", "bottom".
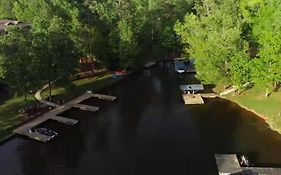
{"left": 252, "top": 0, "right": 281, "bottom": 96}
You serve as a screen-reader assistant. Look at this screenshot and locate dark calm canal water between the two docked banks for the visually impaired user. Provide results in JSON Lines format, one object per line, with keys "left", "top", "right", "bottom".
{"left": 0, "top": 63, "right": 281, "bottom": 175}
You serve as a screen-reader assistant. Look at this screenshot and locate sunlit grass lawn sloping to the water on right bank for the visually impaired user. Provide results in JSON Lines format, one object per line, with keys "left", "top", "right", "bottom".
{"left": 213, "top": 86, "right": 281, "bottom": 133}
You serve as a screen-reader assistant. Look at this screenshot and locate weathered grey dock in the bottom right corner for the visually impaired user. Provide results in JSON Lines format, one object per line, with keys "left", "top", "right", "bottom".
{"left": 215, "top": 154, "right": 281, "bottom": 175}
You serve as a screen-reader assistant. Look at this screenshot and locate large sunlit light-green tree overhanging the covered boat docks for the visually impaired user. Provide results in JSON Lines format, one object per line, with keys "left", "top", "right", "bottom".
{"left": 175, "top": 0, "right": 246, "bottom": 83}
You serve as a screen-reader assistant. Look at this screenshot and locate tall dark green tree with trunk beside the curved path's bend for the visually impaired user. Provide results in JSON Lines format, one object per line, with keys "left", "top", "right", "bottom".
{"left": 14, "top": 0, "right": 81, "bottom": 100}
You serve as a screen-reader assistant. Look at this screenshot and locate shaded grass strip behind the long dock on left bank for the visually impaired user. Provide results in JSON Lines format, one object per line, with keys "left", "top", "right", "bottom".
{"left": 0, "top": 73, "right": 116, "bottom": 140}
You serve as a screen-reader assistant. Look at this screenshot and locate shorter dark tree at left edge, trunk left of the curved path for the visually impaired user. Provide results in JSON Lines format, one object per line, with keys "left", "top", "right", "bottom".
{"left": 1, "top": 27, "right": 39, "bottom": 108}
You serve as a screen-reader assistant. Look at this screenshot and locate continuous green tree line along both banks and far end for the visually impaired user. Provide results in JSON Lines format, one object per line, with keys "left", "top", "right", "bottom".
{"left": 0, "top": 0, "right": 281, "bottom": 108}
